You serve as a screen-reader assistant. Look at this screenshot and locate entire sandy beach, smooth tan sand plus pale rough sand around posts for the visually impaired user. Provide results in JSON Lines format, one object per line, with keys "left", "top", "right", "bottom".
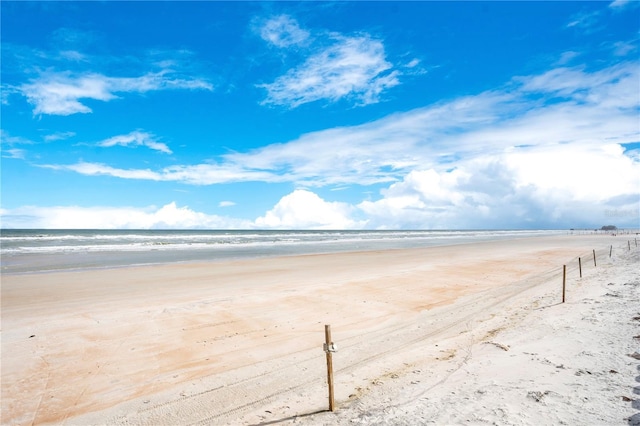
{"left": 2, "top": 235, "right": 640, "bottom": 425}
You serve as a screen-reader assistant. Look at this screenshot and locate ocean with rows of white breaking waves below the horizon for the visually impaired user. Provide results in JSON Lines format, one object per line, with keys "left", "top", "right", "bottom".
{"left": 0, "top": 229, "right": 566, "bottom": 274}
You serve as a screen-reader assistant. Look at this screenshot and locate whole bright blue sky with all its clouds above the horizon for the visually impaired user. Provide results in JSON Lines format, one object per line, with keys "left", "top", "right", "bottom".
{"left": 0, "top": 0, "right": 640, "bottom": 229}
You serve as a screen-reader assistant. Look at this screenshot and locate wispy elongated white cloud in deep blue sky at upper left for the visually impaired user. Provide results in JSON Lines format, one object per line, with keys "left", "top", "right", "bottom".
{"left": 18, "top": 70, "right": 212, "bottom": 115}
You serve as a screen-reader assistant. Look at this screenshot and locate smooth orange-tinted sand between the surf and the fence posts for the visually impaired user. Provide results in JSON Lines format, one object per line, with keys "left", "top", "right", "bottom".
{"left": 2, "top": 235, "right": 636, "bottom": 424}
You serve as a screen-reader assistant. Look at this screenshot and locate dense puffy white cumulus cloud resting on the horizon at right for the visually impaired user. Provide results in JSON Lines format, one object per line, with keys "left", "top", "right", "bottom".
{"left": 358, "top": 144, "right": 640, "bottom": 229}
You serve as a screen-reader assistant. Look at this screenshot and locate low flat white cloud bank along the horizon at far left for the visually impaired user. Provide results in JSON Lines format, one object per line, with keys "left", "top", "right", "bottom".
{"left": 0, "top": 202, "right": 251, "bottom": 229}
